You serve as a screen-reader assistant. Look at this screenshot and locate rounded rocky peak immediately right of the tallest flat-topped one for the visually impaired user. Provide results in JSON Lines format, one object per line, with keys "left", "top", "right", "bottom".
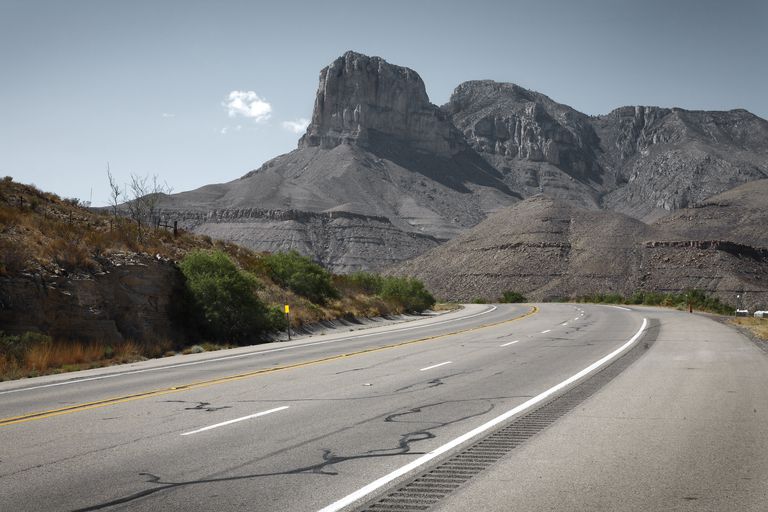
{"left": 443, "top": 80, "right": 616, "bottom": 209}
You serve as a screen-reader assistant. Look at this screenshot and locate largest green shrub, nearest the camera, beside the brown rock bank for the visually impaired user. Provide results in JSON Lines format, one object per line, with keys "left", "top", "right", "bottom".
{"left": 179, "top": 250, "right": 275, "bottom": 343}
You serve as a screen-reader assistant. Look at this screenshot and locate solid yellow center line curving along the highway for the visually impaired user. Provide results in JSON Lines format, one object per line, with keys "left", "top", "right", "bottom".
{"left": 0, "top": 306, "right": 539, "bottom": 427}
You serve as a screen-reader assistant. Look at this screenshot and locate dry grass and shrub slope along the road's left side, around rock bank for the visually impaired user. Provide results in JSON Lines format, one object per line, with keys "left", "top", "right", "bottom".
{"left": 0, "top": 177, "right": 435, "bottom": 380}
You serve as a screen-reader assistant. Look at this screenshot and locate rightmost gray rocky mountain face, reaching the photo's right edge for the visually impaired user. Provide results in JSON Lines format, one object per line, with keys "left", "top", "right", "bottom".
{"left": 594, "top": 107, "right": 768, "bottom": 219}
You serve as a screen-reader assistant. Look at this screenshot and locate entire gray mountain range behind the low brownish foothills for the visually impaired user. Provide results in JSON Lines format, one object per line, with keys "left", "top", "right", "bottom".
{"left": 156, "top": 52, "right": 768, "bottom": 272}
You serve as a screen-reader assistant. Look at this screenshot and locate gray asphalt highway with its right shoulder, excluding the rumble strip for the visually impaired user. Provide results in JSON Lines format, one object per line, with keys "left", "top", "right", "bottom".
{"left": 0, "top": 304, "right": 768, "bottom": 511}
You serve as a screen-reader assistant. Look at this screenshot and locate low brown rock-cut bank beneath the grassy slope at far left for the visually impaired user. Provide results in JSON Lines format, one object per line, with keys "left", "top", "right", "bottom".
{"left": 0, "top": 254, "right": 184, "bottom": 343}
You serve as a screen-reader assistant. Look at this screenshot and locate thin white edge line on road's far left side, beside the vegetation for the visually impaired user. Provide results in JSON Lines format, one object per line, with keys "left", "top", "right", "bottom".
{"left": 0, "top": 306, "right": 498, "bottom": 395}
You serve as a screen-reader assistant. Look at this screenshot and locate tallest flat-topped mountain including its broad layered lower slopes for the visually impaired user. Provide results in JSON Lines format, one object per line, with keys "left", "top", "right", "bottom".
{"left": 161, "top": 52, "right": 521, "bottom": 272}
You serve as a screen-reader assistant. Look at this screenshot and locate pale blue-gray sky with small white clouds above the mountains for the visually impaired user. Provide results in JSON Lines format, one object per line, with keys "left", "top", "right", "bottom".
{"left": 0, "top": 0, "right": 768, "bottom": 205}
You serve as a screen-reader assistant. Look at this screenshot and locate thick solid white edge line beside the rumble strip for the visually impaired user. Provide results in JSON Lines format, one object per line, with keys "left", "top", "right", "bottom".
{"left": 319, "top": 318, "right": 648, "bottom": 512}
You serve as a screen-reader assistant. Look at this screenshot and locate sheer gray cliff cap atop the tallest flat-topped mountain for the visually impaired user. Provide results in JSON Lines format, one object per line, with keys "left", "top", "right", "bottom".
{"left": 299, "top": 52, "right": 466, "bottom": 157}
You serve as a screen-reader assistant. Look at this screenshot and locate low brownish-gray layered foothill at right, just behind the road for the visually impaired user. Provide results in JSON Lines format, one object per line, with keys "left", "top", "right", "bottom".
{"left": 394, "top": 195, "right": 768, "bottom": 308}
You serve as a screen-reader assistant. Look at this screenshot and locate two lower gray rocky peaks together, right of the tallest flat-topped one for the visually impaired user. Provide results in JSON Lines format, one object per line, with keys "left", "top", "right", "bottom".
{"left": 443, "top": 80, "right": 768, "bottom": 220}
